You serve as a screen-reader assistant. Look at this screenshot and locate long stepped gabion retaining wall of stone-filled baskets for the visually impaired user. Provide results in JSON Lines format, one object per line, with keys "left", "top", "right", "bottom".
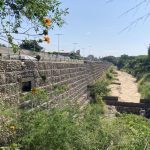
{"left": 0, "top": 61, "right": 111, "bottom": 104}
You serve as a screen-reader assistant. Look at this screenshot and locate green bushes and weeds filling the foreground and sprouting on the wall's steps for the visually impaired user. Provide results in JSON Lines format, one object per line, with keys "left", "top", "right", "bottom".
{"left": 0, "top": 69, "right": 150, "bottom": 150}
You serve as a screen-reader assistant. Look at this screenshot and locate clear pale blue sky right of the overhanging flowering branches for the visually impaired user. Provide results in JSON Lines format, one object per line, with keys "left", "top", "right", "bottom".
{"left": 44, "top": 0, "right": 150, "bottom": 56}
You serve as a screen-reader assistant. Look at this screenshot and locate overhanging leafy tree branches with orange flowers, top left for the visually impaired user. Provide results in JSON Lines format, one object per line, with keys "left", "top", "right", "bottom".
{"left": 0, "top": 0, "right": 68, "bottom": 52}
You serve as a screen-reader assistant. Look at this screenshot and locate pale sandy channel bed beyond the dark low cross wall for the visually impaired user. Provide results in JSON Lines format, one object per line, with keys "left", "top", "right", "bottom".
{"left": 110, "top": 71, "right": 141, "bottom": 103}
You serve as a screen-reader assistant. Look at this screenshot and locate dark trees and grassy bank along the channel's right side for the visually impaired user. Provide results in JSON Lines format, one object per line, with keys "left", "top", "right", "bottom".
{"left": 103, "top": 47, "right": 150, "bottom": 99}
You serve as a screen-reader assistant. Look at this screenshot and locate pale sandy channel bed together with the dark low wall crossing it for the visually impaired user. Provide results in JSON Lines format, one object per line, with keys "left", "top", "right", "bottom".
{"left": 103, "top": 70, "right": 147, "bottom": 117}
